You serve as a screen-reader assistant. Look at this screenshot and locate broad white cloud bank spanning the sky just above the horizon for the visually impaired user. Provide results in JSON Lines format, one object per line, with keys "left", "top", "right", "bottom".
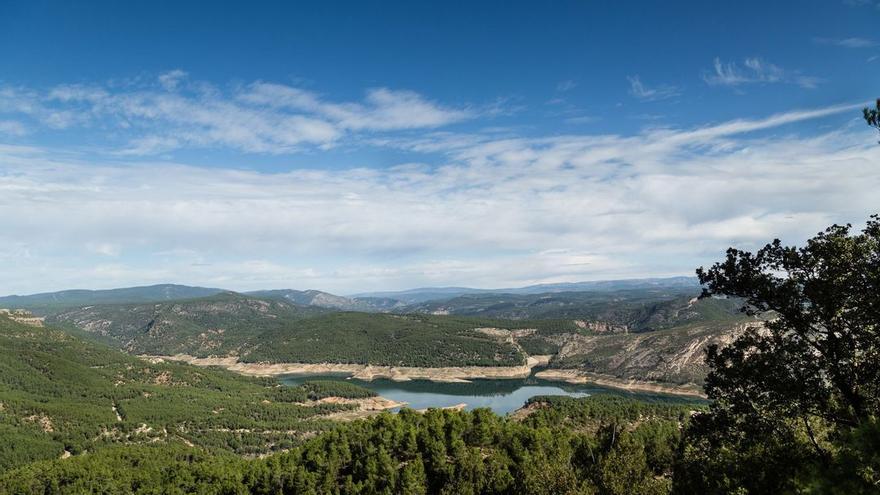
{"left": 0, "top": 101, "right": 880, "bottom": 293}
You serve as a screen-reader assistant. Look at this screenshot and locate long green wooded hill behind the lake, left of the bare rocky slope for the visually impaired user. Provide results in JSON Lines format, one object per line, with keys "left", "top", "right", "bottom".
{"left": 46, "top": 293, "right": 536, "bottom": 366}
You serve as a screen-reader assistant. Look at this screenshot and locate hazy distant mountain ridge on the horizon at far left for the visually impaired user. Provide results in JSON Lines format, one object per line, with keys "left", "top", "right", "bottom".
{"left": 0, "top": 284, "right": 223, "bottom": 314}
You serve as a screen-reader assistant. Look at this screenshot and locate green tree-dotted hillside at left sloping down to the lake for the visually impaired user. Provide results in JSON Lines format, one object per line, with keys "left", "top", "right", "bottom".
{"left": 0, "top": 316, "right": 382, "bottom": 471}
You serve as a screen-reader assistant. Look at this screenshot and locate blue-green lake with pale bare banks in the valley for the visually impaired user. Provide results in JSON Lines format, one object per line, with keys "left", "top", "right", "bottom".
{"left": 281, "top": 375, "right": 704, "bottom": 414}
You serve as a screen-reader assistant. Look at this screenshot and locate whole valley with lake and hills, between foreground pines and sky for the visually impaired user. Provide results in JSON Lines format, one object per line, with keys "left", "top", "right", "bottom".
{"left": 0, "top": 281, "right": 758, "bottom": 487}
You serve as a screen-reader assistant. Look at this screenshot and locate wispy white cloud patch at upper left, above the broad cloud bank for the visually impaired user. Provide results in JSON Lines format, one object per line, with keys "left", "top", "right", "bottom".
{"left": 0, "top": 77, "right": 476, "bottom": 155}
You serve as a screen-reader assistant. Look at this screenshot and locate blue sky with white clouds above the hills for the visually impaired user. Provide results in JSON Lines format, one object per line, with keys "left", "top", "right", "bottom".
{"left": 0, "top": 0, "right": 880, "bottom": 295}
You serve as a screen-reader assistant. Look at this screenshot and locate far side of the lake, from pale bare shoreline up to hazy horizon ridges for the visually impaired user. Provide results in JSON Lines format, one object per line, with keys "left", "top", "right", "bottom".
{"left": 3, "top": 278, "right": 760, "bottom": 395}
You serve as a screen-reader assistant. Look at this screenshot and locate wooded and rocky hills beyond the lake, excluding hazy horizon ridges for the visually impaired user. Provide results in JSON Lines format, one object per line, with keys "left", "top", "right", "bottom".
{"left": 46, "top": 290, "right": 754, "bottom": 391}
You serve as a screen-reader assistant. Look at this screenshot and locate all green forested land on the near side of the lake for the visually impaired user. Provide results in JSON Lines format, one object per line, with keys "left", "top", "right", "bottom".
{"left": 0, "top": 317, "right": 693, "bottom": 493}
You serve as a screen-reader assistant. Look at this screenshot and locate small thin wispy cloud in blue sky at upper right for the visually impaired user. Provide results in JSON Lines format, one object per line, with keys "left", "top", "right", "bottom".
{"left": 703, "top": 58, "right": 822, "bottom": 88}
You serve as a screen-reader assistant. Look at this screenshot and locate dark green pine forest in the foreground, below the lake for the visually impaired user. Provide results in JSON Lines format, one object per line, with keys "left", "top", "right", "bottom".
{"left": 0, "top": 396, "right": 691, "bottom": 495}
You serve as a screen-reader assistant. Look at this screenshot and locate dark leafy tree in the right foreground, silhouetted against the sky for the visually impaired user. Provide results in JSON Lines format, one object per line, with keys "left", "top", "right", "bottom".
{"left": 676, "top": 219, "right": 880, "bottom": 493}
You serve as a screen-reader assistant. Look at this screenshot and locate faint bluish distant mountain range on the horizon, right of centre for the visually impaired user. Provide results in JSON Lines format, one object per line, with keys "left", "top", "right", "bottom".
{"left": 350, "top": 277, "right": 700, "bottom": 304}
